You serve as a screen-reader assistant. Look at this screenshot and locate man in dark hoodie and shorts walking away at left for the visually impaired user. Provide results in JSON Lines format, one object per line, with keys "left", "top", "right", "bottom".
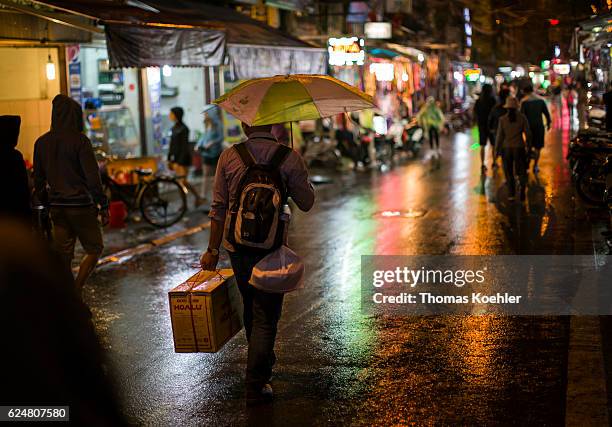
{"left": 34, "top": 95, "right": 108, "bottom": 300}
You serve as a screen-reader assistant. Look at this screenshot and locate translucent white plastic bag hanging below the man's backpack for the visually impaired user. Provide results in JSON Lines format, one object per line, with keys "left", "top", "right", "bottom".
{"left": 249, "top": 245, "right": 304, "bottom": 293}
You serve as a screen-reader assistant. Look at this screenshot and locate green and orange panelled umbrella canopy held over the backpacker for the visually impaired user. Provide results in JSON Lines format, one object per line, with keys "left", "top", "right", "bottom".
{"left": 214, "top": 74, "right": 374, "bottom": 126}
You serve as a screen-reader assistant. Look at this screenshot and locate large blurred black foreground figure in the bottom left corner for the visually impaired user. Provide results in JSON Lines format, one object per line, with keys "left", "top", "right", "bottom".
{"left": 0, "top": 220, "right": 127, "bottom": 426}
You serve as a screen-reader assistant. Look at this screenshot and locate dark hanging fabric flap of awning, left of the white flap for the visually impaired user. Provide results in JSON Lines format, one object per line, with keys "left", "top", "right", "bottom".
{"left": 106, "top": 25, "right": 226, "bottom": 68}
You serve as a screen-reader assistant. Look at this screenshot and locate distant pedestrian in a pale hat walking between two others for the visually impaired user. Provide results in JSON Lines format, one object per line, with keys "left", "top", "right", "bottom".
{"left": 495, "top": 96, "right": 531, "bottom": 201}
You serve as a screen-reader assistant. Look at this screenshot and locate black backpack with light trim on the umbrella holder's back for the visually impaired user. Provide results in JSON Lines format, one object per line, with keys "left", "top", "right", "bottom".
{"left": 227, "top": 142, "right": 291, "bottom": 252}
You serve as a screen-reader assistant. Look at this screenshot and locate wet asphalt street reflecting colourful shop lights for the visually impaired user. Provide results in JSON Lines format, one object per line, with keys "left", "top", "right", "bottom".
{"left": 85, "top": 115, "right": 598, "bottom": 426}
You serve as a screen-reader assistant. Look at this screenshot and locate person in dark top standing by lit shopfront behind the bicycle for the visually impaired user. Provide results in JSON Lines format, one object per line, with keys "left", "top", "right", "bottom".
{"left": 168, "top": 107, "right": 205, "bottom": 207}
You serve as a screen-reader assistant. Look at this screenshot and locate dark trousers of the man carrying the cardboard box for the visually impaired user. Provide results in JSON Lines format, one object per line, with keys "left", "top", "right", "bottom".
{"left": 230, "top": 252, "right": 284, "bottom": 391}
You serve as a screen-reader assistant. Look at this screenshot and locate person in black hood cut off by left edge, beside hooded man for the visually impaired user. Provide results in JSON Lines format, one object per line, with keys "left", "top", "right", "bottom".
{"left": 0, "top": 116, "right": 32, "bottom": 222}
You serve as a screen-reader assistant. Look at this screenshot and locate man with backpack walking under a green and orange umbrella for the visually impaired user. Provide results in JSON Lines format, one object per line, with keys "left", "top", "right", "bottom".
{"left": 200, "top": 75, "right": 373, "bottom": 401}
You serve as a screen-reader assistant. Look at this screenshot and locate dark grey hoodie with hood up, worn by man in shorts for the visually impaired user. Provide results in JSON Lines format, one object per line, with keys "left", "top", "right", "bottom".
{"left": 34, "top": 95, "right": 108, "bottom": 207}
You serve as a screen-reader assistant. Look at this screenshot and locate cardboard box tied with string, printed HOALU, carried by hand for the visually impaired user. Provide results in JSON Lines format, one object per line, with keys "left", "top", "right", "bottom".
{"left": 168, "top": 269, "right": 242, "bottom": 353}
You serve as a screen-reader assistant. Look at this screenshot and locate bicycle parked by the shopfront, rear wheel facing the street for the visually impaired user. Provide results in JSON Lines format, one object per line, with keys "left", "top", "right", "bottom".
{"left": 96, "top": 153, "right": 187, "bottom": 228}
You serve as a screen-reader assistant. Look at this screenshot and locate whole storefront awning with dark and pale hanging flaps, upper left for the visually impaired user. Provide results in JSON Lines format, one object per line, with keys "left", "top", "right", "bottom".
{"left": 29, "top": 0, "right": 327, "bottom": 72}
